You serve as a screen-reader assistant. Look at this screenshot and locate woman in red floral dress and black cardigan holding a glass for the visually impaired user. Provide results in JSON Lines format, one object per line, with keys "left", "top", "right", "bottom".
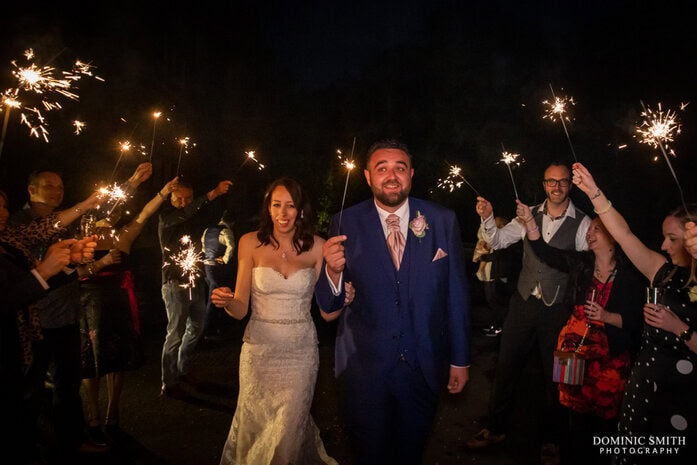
{"left": 517, "top": 201, "right": 644, "bottom": 465}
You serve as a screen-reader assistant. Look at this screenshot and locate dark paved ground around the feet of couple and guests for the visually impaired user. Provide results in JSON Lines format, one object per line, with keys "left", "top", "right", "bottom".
{"left": 69, "top": 282, "right": 539, "bottom": 465}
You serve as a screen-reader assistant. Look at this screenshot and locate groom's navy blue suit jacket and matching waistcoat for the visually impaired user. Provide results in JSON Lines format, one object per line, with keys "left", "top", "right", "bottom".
{"left": 316, "top": 197, "right": 470, "bottom": 392}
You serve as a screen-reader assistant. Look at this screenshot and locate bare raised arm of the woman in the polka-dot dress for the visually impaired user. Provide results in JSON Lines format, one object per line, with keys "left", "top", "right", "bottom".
{"left": 573, "top": 163, "right": 666, "bottom": 282}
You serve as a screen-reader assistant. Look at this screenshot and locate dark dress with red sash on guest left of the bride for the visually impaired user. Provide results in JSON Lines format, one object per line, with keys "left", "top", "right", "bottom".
{"left": 80, "top": 251, "right": 144, "bottom": 379}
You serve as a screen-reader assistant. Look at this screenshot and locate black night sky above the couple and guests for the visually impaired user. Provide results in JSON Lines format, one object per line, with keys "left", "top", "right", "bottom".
{"left": 0, "top": 0, "right": 697, "bottom": 245}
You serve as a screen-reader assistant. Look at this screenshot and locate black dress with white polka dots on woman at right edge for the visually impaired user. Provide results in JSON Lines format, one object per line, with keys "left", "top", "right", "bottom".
{"left": 618, "top": 263, "right": 697, "bottom": 464}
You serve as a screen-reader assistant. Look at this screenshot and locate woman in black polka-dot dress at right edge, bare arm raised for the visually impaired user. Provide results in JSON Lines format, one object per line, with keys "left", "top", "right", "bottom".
{"left": 573, "top": 163, "right": 697, "bottom": 464}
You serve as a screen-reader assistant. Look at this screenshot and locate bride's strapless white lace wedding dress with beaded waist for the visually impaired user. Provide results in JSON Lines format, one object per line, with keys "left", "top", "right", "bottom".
{"left": 220, "top": 267, "right": 337, "bottom": 465}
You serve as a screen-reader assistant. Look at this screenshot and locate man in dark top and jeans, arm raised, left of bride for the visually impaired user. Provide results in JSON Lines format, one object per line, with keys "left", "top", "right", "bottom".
{"left": 157, "top": 179, "right": 232, "bottom": 399}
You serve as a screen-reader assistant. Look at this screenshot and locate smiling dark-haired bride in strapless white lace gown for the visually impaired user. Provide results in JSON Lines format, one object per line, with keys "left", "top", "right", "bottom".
{"left": 211, "top": 178, "right": 353, "bottom": 465}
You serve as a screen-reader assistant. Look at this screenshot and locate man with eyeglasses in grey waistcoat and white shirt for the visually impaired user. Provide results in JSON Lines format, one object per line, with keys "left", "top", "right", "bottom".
{"left": 466, "top": 163, "right": 590, "bottom": 464}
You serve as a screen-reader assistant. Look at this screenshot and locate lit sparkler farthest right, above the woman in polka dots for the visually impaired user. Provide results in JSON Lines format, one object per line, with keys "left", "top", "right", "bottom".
{"left": 637, "top": 102, "right": 690, "bottom": 216}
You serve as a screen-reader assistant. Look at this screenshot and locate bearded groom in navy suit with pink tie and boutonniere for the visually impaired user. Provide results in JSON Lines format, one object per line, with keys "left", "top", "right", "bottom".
{"left": 316, "top": 140, "right": 470, "bottom": 465}
